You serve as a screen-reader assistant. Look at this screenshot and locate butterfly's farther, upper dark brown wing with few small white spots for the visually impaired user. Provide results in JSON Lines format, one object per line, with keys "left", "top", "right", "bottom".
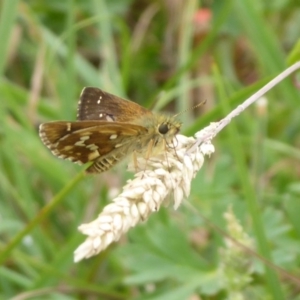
{"left": 77, "top": 87, "right": 152, "bottom": 122}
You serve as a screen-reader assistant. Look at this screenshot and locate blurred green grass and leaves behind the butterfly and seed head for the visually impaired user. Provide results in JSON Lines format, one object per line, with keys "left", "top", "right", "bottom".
{"left": 0, "top": 0, "right": 300, "bottom": 300}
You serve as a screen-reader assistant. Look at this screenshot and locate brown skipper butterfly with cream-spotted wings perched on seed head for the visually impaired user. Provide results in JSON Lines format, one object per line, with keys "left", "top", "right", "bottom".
{"left": 39, "top": 87, "right": 181, "bottom": 173}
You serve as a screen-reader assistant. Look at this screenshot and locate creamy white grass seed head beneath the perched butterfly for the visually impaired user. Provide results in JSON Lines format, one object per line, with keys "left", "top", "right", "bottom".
{"left": 74, "top": 132, "right": 214, "bottom": 262}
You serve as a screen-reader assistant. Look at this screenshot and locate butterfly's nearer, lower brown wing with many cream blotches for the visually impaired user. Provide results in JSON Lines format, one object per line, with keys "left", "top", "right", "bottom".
{"left": 40, "top": 121, "right": 147, "bottom": 173}
